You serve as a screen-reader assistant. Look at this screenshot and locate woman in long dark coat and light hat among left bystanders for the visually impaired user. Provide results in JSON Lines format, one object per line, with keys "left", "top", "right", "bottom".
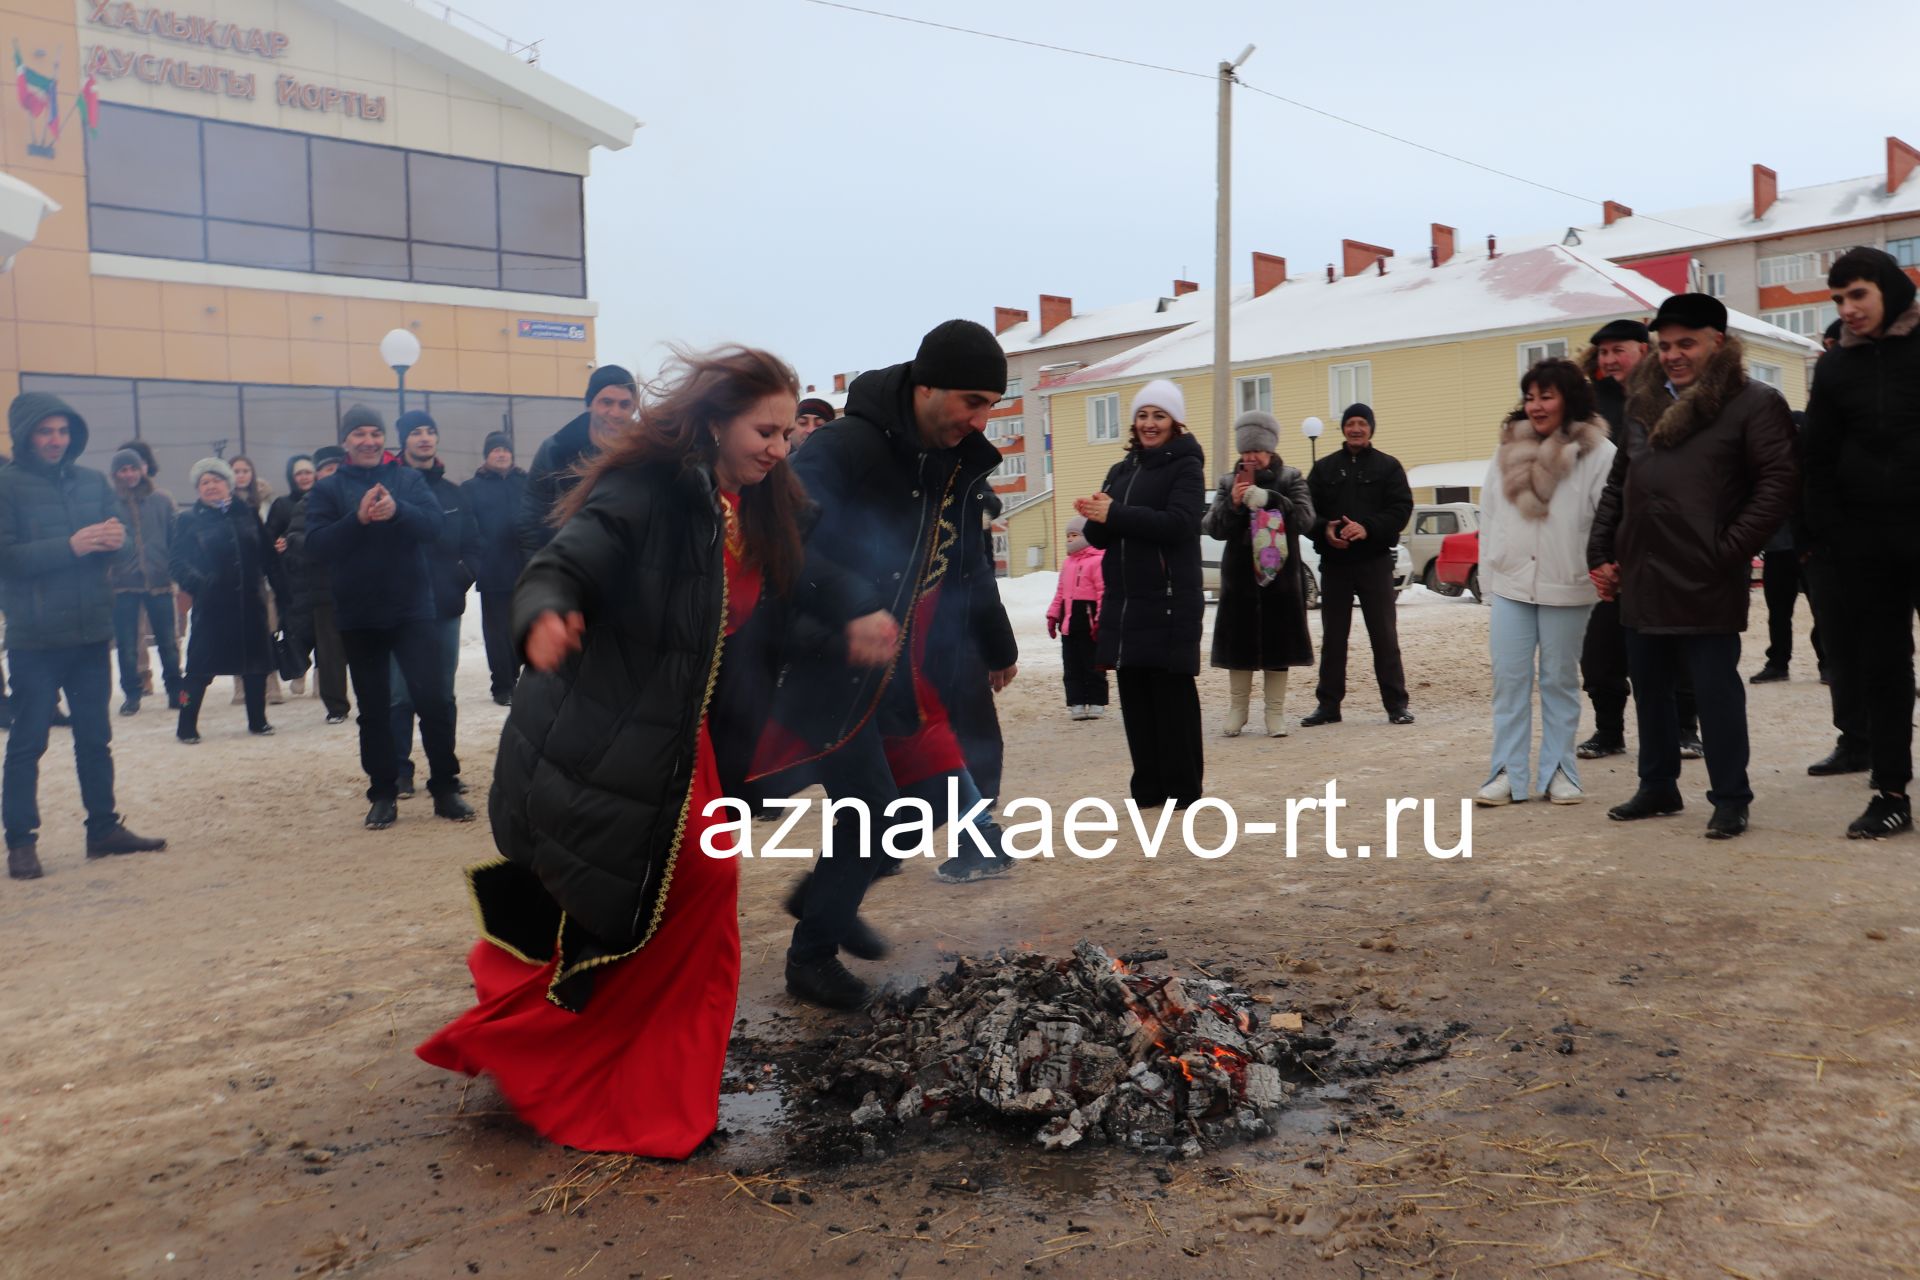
{"left": 169, "top": 459, "right": 286, "bottom": 743}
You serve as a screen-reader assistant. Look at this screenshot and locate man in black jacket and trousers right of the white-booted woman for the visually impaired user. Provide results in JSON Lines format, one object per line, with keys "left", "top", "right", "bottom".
{"left": 1300, "top": 405, "right": 1413, "bottom": 727}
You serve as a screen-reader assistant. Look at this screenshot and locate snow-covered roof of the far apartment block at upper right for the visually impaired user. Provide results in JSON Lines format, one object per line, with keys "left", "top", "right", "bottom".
{"left": 1509, "top": 173, "right": 1920, "bottom": 259}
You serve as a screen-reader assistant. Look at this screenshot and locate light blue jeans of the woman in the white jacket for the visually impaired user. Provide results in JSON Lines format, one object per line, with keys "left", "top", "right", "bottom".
{"left": 1486, "top": 595, "right": 1594, "bottom": 800}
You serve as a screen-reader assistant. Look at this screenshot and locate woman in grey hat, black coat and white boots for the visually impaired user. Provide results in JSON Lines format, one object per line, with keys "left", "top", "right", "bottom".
{"left": 1200, "top": 413, "right": 1313, "bottom": 737}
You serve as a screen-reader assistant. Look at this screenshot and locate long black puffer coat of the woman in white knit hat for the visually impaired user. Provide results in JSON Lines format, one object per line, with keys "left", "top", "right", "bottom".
{"left": 1087, "top": 432, "right": 1206, "bottom": 676}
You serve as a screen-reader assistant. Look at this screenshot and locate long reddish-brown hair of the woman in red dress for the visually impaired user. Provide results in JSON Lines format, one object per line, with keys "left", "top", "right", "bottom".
{"left": 549, "top": 345, "right": 806, "bottom": 595}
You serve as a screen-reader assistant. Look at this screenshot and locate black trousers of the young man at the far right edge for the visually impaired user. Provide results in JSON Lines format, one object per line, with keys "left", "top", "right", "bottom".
{"left": 1837, "top": 555, "right": 1920, "bottom": 791}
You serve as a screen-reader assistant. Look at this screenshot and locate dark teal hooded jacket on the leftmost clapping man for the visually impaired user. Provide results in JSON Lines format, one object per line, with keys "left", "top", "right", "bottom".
{"left": 0, "top": 391, "right": 121, "bottom": 649}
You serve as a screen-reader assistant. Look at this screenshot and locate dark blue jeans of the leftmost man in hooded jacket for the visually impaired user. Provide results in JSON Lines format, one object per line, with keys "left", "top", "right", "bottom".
{"left": 0, "top": 640, "right": 118, "bottom": 848}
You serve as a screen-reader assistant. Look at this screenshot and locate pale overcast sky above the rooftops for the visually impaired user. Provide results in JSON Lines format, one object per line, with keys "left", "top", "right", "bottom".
{"left": 455, "top": 0, "right": 1920, "bottom": 386}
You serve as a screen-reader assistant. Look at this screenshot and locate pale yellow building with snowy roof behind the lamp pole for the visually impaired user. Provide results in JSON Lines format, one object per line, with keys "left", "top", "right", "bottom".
{"left": 1044, "top": 246, "right": 1820, "bottom": 574}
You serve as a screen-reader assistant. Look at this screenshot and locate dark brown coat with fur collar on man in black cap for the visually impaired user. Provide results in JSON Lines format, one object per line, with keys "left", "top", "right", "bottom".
{"left": 1586, "top": 338, "right": 1799, "bottom": 635}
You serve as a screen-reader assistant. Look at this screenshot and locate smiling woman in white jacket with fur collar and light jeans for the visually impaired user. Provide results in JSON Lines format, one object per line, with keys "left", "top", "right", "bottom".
{"left": 1476, "top": 359, "right": 1613, "bottom": 804}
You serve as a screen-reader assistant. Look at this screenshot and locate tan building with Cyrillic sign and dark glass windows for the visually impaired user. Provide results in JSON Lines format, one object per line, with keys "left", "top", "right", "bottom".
{"left": 0, "top": 0, "right": 637, "bottom": 477}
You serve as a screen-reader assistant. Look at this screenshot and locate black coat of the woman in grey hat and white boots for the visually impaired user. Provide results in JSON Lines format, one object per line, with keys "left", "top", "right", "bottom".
{"left": 1200, "top": 466, "right": 1313, "bottom": 672}
